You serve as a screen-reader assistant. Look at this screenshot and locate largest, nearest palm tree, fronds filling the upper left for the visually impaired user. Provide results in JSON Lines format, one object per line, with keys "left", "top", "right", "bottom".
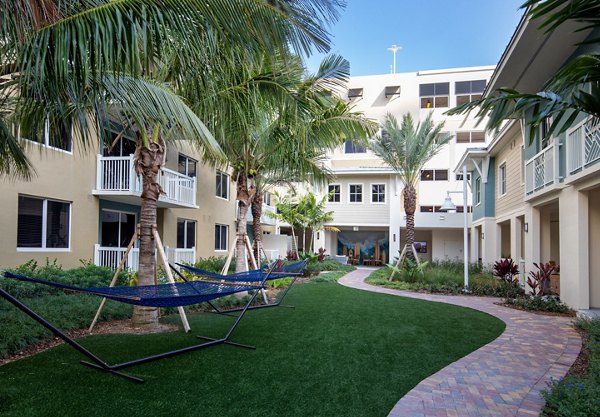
{"left": 0, "top": 0, "right": 346, "bottom": 322}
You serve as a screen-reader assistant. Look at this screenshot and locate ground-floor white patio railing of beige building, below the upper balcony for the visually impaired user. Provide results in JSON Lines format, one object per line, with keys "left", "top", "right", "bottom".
{"left": 94, "top": 244, "right": 196, "bottom": 271}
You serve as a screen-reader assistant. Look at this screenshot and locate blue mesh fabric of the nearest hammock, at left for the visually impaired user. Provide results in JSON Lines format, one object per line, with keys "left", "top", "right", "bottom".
{"left": 4, "top": 271, "right": 267, "bottom": 307}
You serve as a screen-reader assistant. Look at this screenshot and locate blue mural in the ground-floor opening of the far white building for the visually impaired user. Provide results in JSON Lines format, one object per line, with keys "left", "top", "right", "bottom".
{"left": 337, "top": 231, "right": 389, "bottom": 262}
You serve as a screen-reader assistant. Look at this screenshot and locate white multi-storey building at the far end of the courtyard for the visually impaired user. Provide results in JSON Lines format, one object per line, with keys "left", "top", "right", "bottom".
{"left": 316, "top": 66, "right": 494, "bottom": 264}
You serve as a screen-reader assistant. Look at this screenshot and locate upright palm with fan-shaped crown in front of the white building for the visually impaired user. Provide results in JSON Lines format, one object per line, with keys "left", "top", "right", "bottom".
{"left": 369, "top": 113, "right": 451, "bottom": 256}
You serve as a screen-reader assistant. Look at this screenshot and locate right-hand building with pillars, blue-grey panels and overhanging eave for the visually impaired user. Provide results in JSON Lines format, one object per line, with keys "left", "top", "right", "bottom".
{"left": 456, "top": 10, "right": 600, "bottom": 311}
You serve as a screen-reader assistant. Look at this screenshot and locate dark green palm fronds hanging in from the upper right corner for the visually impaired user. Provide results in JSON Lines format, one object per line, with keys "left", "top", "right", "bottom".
{"left": 447, "top": 0, "right": 600, "bottom": 140}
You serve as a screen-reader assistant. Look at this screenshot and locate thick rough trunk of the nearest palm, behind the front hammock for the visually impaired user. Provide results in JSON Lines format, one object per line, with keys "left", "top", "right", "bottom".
{"left": 132, "top": 138, "right": 165, "bottom": 327}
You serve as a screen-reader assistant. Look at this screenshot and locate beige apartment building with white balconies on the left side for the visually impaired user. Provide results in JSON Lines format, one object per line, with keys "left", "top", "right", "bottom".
{"left": 0, "top": 127, "right": 274, "bottom": 269}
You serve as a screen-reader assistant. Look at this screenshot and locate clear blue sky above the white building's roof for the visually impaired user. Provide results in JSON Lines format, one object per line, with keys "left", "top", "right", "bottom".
{"left": 307, "top": 0, "right": 524, "bottom": 76}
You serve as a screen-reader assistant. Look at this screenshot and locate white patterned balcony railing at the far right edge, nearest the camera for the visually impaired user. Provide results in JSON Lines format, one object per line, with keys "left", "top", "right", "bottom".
{"left": 567, "top": 117, "right": 600, "bottom": 175}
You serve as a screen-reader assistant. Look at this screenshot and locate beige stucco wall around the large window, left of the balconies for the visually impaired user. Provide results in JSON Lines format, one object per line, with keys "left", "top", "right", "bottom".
{"left": 0, "top": 142, "right": 99, "bottom": 268}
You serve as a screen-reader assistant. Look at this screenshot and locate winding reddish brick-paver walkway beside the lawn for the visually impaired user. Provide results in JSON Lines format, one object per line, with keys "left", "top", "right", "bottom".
{"left": 339, "top": 268, "right": 581, "bottom": 417}
